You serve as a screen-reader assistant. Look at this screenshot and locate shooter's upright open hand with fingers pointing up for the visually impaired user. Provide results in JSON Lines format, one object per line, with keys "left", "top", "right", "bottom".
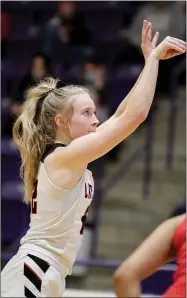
{"left": 141, "top": 20, "right": 159, "bottom": 61}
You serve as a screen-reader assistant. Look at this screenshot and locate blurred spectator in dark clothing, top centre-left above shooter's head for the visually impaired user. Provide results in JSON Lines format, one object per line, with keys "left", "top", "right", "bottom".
{"left": 42, "top": 1, "right": 92, "bottom": 56}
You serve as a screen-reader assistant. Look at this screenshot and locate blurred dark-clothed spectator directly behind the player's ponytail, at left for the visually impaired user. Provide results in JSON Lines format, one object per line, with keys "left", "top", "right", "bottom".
{"left": 2, "top": 53, "right": 51, "bottom": 136}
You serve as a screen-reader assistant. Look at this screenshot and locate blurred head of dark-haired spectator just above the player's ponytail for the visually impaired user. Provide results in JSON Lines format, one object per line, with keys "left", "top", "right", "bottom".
{"left": 30, "top": 53, "right": 51, "bottom": 80}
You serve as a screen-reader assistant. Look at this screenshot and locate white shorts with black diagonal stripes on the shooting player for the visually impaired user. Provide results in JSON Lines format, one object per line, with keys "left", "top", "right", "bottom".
{"left": 1, "top": 254, "right": 65, "bottom": 298}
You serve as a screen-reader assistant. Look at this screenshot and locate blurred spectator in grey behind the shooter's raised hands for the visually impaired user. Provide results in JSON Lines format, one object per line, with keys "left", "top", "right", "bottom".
{"left": 116, "top": 1, "right": 186, "bottom": 93}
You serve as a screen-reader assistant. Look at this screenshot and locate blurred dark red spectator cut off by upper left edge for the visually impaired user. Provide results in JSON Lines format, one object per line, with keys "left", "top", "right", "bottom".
{"left": 1, "top": 12, "right": 11, "bottom": 59}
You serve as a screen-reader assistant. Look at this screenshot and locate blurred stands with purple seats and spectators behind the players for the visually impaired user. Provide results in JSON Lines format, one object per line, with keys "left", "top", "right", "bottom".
{"left": 1, "top": 1, "right": 186, "bottom": 297}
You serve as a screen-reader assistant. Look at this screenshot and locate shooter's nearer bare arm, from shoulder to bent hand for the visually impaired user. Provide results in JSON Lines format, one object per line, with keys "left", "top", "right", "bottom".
{"left": 55, "top": 37, "right": 186, "bottom": 167}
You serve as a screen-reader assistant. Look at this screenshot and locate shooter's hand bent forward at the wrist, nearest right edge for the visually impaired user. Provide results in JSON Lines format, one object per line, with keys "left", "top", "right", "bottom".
{"left": 151, "top": 36, "right": 187, "bottom": 60}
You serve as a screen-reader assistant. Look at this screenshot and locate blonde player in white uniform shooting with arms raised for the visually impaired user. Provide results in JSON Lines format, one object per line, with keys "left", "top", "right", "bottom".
{"left": 1, "top": 19, "right": 186, "bottom": 297}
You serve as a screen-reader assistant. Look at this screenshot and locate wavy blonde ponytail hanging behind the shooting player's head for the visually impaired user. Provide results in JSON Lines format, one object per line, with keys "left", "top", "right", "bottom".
{"left": 13, "top": 88, "right": 49, "bottom": 204}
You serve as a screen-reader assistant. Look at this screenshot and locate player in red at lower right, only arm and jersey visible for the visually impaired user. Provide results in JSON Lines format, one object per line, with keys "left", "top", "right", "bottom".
{"left": 114, "top": 215, "right": 186, "bottom": 297}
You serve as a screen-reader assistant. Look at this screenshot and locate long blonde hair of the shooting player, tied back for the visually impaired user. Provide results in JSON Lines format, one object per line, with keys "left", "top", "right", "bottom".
{"left": 13, "top": 77, "right": 88, "bottom": 204}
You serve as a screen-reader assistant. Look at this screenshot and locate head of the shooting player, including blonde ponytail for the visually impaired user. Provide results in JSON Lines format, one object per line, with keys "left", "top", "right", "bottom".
{"left": 13, "top": 78, "right": 98, "bottom": 202}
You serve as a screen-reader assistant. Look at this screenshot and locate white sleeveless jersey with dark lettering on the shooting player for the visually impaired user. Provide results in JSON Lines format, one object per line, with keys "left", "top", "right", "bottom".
{"left": 21, "top": 144, "right": 94, "bottom": 274}
